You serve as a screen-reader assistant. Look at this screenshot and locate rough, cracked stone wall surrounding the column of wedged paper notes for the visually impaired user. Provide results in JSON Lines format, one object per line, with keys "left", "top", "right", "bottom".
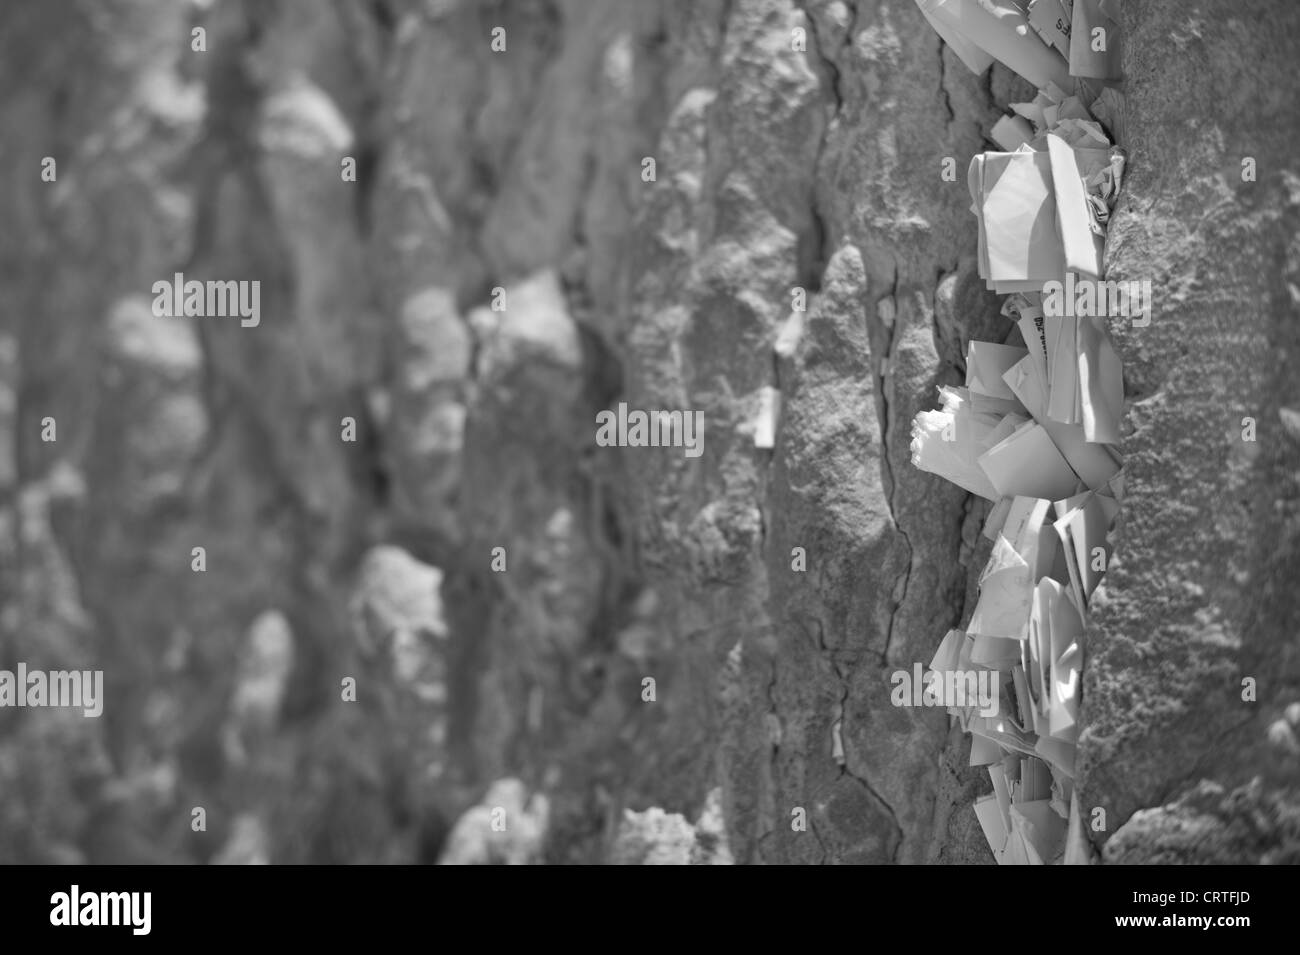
{"left": 0, "top": 0, "right": 1300, "bottom": 864}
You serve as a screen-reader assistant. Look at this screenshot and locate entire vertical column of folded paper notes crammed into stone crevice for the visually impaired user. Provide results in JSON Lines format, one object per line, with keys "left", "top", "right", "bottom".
{"left": 911, "top": 0, "right": 1125, "bottom": 864}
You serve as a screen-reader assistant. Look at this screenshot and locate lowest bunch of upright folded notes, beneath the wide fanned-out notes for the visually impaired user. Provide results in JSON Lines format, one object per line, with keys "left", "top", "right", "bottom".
{"left": 930, "top": 477, "right": 1119, "bottom": 863}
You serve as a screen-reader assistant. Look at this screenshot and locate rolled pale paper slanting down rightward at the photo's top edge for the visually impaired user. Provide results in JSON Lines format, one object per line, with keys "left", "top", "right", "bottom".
{"left": 917, "top": 0, "right": 1078, "bottom": 88}
